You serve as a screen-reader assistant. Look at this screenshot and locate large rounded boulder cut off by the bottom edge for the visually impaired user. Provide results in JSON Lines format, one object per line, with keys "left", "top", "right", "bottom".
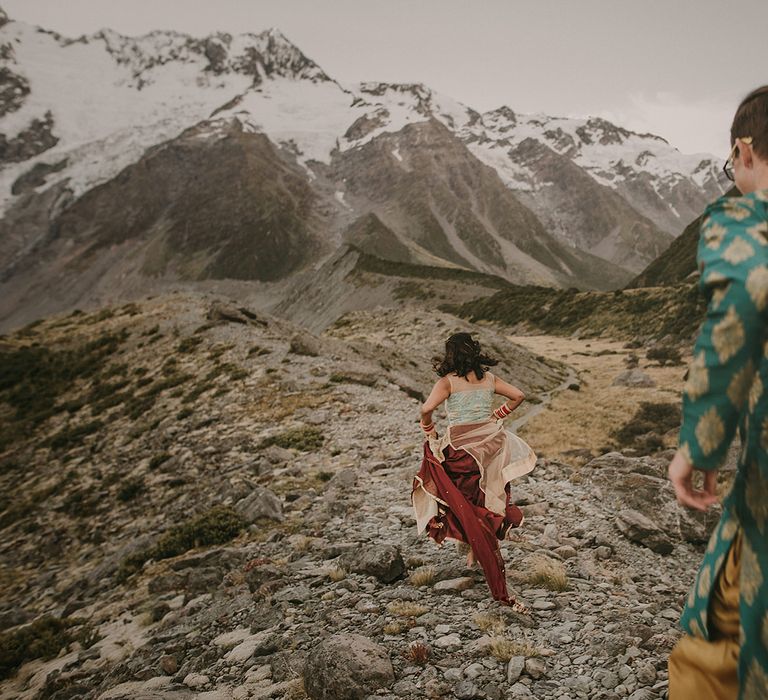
{"left": 303, "top": 634, "right": 395, "bottom": 700}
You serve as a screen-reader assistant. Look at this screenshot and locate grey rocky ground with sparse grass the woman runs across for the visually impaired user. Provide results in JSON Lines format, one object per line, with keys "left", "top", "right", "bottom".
{"left": 0, "top": 295, "right": 716, "bottom": 700}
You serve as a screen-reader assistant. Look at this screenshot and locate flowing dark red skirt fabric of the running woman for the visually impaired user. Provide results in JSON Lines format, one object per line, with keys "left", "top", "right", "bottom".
{"left": 414, "top": 442, "right": 523, "bottom": 603}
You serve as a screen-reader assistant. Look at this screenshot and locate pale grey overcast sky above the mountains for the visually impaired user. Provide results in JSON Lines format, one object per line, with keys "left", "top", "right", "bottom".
{"left": 6, "top": 0, "right": 768, "bottom": 157}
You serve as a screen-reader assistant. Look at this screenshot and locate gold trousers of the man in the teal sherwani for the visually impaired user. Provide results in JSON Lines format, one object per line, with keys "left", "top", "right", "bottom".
{"left": 669, "top": 529, "right": 742, "bottom": 700}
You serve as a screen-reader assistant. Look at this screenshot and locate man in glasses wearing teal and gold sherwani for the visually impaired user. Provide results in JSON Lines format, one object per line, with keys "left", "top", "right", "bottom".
{"left": 669, "top": 86, "right": 768, "bottom": 700}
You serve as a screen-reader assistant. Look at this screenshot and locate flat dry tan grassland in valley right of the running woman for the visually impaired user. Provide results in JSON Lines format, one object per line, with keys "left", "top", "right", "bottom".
{"left": 510, "top": 335, "right": 688, "bottom": 462}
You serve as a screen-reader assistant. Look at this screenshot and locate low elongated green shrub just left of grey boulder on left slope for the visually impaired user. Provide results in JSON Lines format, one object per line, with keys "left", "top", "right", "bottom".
{"left": 117, "top": 506, "right": 245, "bottom": 581}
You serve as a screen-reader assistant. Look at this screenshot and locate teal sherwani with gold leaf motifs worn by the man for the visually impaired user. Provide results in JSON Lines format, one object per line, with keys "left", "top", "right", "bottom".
{"left": 680, "top": 190, "right": 768, "bottom": 700}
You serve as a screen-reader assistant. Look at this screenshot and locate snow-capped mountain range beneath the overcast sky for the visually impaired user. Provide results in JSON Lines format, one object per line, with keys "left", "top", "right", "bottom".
{"left": 0, "top": 6, "right": 721, "bottom": 330}
